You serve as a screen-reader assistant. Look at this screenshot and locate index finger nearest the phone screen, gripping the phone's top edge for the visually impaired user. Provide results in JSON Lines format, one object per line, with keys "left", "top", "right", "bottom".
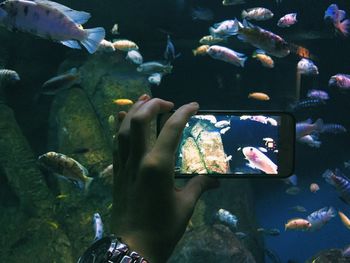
{"left": 154, "top": 102, "right": 199, "bottom": 156}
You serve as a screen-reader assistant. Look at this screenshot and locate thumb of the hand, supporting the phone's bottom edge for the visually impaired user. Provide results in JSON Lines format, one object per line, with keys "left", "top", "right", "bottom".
{"left": 180, "top": 175, "right": 220, "bottom": 211}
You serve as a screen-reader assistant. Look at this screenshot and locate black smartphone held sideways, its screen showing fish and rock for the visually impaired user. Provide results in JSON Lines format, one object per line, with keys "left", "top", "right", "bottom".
{"left": 157, "top": 111, "right": 295, "bottom": 178}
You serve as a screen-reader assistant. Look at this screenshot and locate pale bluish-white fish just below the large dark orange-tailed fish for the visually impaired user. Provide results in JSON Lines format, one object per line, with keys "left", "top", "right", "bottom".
{"left": 207, "top": 45, "right": 247, "bottom": 67}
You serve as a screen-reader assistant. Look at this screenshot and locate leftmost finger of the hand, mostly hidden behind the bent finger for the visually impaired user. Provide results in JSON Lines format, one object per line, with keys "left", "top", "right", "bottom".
{"left": 113, "top": 94, "right": 150, "bottom": 163}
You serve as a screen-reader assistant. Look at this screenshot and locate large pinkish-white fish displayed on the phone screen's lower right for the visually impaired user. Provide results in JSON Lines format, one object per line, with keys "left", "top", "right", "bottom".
{"left": 242, "top": 146, "right": 278, "bottom": 174}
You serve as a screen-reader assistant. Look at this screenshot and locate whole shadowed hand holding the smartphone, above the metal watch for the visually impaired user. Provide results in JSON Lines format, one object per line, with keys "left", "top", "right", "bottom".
{"left": 111, "top": 95, "right": 218, "bottom": 263}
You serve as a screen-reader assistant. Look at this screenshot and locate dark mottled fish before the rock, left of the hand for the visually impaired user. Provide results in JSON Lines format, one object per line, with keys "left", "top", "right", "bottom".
{"left": 38, "top": 152, "right": 93, "bottom": 191}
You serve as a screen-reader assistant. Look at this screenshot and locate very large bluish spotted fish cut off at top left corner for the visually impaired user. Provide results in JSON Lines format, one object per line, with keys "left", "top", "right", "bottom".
{"left": 0, "top": 0, "right": 105, "bottom": 54}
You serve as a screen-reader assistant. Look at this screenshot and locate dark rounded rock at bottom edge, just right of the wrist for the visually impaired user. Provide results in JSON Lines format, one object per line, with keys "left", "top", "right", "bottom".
{"left": 168, "top": 224, "right": 256, "bottom": 263}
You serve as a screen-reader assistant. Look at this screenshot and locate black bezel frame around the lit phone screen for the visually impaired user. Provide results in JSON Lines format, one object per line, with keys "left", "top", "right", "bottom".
{"left": 157, "top": 110, "right": 296, "bottom": 179}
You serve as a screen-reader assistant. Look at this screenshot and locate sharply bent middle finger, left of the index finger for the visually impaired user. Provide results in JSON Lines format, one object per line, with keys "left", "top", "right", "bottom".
{"left": 130, "top": 98, "right": 174, "bottom": 163}
